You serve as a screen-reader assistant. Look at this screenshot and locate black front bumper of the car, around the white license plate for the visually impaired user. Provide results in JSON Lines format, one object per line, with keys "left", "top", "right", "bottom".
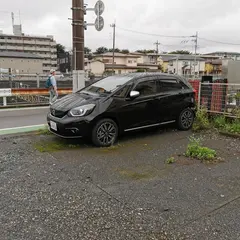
{"left": 47, "top": 113, "right": 91, "bottom": 138}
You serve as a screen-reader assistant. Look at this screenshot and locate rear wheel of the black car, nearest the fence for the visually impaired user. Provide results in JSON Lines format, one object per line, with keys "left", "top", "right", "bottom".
{"left": 177, "top": 108, "right": 195, "bottom": 131}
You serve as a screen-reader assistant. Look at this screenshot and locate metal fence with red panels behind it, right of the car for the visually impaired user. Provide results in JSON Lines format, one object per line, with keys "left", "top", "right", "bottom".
{"left": 190, "top": 80, "right": 240, "bottom": 118}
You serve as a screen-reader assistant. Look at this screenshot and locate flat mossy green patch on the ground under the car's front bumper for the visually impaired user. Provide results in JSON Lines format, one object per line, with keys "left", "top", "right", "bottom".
{"left": 34, "top": 141, "right": 80, "bottom": 153}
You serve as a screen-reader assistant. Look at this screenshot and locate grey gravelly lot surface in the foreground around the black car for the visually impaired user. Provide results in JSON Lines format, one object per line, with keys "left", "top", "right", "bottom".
{"left": 0, "top": 130, "right": 240, "bottom": 240}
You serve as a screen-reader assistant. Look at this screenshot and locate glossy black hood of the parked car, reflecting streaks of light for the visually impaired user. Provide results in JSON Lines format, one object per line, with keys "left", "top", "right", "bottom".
{"left": 51, "top": 93, "right": 100, "bottom": 112}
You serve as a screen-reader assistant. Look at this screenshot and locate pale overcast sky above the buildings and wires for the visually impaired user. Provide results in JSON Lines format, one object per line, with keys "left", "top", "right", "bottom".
{"left": 0, "top": 0, "right": 240, "bottom": 53}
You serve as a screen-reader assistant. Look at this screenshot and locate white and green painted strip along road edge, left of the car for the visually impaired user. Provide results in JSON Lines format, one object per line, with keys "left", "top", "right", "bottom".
{"left": 0, "top": 124, "right": 47, "bottom": 136}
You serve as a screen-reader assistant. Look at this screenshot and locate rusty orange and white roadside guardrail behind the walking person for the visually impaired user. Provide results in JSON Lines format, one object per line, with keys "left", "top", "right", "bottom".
{"left": 0, "top": 88, "right": 72, "bottom": 107}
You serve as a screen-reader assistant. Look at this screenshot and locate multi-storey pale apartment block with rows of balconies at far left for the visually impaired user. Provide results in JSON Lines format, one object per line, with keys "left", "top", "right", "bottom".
{"left": 0, "top": 33, "right": 57, "bottom": 73}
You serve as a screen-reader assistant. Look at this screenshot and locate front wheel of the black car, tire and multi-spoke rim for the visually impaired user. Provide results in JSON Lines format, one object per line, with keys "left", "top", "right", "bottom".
{"left": 92, "top": 118, "right": 118, "bottom": 147}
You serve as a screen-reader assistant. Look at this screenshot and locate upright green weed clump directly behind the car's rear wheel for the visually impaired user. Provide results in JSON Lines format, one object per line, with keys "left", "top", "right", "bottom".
{"left": 192, "top": 108, "right": 210, "bottom": 131}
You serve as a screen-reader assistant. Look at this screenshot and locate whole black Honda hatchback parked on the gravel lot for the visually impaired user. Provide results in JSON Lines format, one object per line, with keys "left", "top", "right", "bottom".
{"left": 47, "top": 73, "right": 195, "bottom": 147}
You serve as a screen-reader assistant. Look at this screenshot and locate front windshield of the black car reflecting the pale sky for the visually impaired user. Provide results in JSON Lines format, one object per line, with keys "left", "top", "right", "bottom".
{"left": 81, "top": 76, "right": 132, "bottom": 94}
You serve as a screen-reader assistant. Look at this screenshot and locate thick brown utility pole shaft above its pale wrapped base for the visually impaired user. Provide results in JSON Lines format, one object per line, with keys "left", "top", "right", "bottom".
{"left": 72, "top": 0, "right": 84, "bottom": 70}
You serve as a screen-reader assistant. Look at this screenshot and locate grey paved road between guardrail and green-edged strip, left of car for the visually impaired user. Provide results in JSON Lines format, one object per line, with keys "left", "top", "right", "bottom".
{"left": 0, "top": 107, "right": 49, "bottom": 130}
